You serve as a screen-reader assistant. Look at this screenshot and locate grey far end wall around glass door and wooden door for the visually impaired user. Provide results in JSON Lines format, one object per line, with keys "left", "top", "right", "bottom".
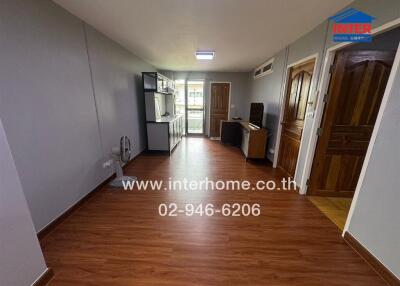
{"left": 173, "top": 71, "right": 250, "bottom": 134}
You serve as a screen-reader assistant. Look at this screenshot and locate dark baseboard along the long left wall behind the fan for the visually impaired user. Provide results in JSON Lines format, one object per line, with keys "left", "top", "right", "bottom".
{"left": 37, "top": 150, "right": 144, "bottom": 241}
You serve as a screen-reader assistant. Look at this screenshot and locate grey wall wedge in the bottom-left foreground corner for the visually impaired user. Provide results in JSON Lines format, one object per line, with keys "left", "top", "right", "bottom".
{"left": 0, "top": 120, "right": 47, "bottom": 286}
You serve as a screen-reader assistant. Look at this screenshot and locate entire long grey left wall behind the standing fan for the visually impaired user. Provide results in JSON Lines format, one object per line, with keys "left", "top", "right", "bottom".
{"left": 0, "top": 0, "right": 154, "bottom": 231}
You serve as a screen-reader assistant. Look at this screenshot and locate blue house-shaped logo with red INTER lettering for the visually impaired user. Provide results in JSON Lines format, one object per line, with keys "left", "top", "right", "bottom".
{"left": 329, "top": 8, "right": 375, "bottom": 43}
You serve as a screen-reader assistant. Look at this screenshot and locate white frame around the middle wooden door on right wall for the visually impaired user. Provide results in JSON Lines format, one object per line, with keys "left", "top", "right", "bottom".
{"left": 273, "top": 53, "right": 318, "bottom": 181}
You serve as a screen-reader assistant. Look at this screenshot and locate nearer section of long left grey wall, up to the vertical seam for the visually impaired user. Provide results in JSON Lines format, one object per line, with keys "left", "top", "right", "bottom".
{"left": 0, "top": 0, "right": 104, "bottom": 230}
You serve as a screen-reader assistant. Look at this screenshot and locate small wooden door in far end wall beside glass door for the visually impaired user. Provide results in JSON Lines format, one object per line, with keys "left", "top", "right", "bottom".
{"left": 210, "top": 83, "right": 230, "bottom": 137}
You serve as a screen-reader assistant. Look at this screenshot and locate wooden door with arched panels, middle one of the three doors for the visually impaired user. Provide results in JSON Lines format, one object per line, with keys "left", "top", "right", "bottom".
{"left": 278, "top": 61, "right": 315, "bottom": 177}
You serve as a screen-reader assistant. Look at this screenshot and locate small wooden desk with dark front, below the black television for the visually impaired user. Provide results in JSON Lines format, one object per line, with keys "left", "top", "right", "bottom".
{"left": 221, "top": 120, "right": 267, "bottom": 159}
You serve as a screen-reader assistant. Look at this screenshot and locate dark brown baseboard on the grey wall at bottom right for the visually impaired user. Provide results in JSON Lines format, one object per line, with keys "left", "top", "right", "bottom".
{"left": 344, "top": 231, "right": 400, "bottom": 286}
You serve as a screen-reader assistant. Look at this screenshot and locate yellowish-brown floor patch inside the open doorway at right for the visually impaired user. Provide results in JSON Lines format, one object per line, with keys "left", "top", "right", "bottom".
{"left": 307, "top": 196, "right": 352, "bottom": 230}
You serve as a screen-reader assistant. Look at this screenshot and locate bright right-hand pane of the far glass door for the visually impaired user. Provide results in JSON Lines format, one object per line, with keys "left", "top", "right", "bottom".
{"left": 186, "top": 80, "right": 204, "bottom": 135}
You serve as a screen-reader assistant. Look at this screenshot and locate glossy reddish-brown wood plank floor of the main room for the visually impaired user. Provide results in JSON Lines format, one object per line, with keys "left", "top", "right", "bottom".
{"left": 42, "top": 138, "right": 384, "bottom": 286}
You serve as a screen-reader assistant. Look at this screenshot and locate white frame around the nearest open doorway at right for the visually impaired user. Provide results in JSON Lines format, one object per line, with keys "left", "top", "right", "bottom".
{"left": 294, "top": 18, "right": 400, "bottom": 236}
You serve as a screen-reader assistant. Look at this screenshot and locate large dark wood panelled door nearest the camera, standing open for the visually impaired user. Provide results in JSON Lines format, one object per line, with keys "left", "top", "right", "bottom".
{"left": 308, "top": 50, "right": 395, "bottom": 197}
